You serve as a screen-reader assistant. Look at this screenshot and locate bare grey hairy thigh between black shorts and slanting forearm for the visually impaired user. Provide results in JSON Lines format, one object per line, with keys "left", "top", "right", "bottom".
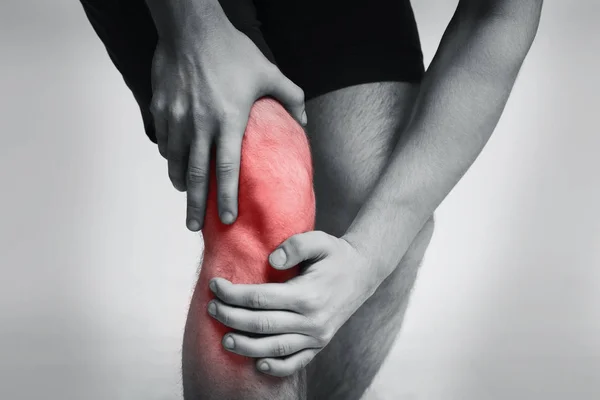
{"left": 306, "top": 82, "right": 419, "bottom": 235}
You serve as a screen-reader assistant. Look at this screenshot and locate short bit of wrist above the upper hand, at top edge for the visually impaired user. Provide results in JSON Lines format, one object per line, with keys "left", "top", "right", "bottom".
{"left": 146, "top": 0, "right": 227, "bottom": 40}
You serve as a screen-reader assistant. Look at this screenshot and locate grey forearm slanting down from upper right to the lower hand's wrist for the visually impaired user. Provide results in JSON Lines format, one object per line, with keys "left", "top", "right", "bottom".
{"left": 344, "top": 0, "right": 542, "bottom": 281}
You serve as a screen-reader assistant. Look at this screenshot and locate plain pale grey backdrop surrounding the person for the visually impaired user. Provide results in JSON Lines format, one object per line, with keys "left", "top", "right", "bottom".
{"left": 0, "top": 0, "right": 600, "bottom": 400}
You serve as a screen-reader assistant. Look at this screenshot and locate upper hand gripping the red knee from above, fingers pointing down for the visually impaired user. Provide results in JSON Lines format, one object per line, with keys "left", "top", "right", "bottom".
{"left": 150, "top": 14, "right": 306, "bottom": 231}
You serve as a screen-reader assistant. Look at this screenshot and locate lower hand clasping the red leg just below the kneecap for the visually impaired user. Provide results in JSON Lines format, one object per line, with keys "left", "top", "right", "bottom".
{"left": 209, "top": 231, "right": 378, "bottom": 377}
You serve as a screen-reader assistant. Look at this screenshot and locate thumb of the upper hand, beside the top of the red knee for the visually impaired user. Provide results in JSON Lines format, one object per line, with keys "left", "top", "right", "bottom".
{"left": 265, "top": 65, "right": 308, "bottom": 126}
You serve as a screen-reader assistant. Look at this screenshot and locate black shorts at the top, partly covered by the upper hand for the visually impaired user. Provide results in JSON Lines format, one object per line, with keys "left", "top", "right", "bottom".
{"left": 81, "top": 0, "right": 425, "bottom": 143}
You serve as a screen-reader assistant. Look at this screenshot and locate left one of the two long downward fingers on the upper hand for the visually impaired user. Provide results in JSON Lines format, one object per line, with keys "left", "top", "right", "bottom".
{"left": 187, "top": 131, "right": 216, "bottom": 232}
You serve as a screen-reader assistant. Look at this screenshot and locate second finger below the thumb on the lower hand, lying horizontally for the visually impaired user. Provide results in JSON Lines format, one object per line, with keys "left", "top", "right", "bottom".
{"left": 208, "top": 299, "right": 311, "bottom": 335}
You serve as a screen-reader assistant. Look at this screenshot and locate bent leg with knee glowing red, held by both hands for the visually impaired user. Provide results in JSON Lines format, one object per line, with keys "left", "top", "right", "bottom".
{"left": 182, "top": 99, "right": 315, "bottom": 400}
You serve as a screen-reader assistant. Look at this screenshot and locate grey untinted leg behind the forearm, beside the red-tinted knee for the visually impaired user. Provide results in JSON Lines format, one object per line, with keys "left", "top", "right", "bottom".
{"left": 307, "top": 82, "right": 433, "bottom": 400}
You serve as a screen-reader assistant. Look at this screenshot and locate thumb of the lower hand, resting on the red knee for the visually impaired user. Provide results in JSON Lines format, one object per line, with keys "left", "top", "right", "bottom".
{"left": 269, "top": 231, "right": 332, "bottom": 269}
